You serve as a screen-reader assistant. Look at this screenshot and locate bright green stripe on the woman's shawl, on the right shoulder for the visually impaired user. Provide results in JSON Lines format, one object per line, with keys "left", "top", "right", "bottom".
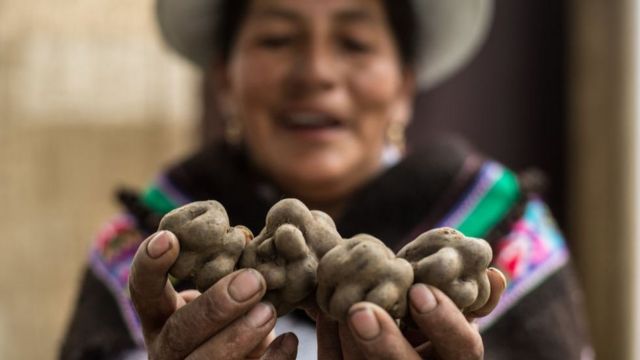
{"left": 458, "top": 169, "right": 520, "bottom": 237}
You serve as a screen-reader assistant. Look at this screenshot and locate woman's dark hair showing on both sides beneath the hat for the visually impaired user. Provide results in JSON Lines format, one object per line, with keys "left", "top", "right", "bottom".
{"left": 215, "top": 0, "right": 420, "bottom": 67}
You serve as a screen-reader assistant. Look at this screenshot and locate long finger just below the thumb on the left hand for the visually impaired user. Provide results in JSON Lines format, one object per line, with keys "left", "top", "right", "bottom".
{"left": 154, "top": 269, "right": 271, "bottom": 358}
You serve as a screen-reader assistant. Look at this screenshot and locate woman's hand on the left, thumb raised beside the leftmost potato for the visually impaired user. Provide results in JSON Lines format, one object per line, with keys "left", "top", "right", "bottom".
{"left": 129, "top": 231, "right": 297, "bottom": 360}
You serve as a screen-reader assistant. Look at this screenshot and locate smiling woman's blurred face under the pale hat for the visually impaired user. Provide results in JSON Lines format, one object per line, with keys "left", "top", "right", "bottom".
{"left": 220, "top": 0, "right": 413, "bottom": 205}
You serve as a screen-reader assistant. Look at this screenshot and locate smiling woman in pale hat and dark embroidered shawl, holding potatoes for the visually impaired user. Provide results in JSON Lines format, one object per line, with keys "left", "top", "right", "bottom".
{"left": 63, "top": 0, "right": 588, "bottom": 359}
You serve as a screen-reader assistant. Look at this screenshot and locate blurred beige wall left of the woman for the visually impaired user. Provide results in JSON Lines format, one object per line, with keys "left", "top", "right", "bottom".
{"left": 0, "top": 0, "right": 198, "bottom": 359}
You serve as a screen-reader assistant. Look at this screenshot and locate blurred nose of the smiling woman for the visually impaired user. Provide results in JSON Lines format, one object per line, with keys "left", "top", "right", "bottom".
{"left": 291, "top": 39, "right": 339, "bottom": 96}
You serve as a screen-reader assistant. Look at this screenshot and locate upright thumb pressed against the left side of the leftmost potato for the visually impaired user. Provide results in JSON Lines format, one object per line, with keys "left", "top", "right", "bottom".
{"left": 129, "top": 231, "right": 182, "bottom": 336}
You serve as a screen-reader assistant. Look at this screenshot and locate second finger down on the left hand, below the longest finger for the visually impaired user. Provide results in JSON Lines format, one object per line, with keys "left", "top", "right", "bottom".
{"left": 187, "top": 302, "right": 276, "bottom": 360}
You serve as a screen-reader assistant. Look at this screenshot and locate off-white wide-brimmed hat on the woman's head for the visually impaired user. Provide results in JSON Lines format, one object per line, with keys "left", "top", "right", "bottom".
{"left": 157, "top": 0, "right": 493, "bottom": 90}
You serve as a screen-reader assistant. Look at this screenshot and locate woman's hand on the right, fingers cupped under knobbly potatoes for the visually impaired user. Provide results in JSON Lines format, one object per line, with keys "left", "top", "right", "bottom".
{"left": 316, "top": 269, "right": 506, "bottom": 360}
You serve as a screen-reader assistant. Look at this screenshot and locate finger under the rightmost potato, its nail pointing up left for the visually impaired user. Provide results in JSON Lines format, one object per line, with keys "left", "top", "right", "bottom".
{"left": 409, "top": 284, "right": 484, "bottom": 359}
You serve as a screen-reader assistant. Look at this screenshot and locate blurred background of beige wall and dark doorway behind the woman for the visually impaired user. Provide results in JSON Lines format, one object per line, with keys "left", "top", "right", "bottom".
{"left": 0, "top": 0, "right": 640, "bottom": 359}
